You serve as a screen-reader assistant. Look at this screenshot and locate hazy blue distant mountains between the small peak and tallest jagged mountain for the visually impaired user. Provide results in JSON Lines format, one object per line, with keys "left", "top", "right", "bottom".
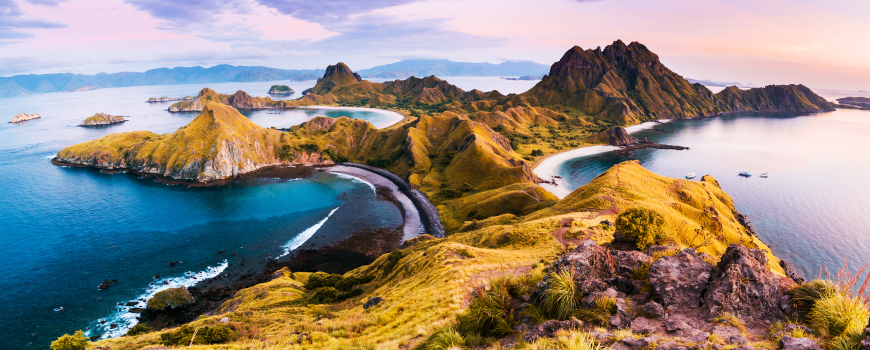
{"left": 357, "top": 60, "right": 550, "bottom": 79}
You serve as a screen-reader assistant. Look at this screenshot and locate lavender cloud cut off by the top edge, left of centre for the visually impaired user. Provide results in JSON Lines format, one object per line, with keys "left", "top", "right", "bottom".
{"left": 259, "top": 0, "right": 420, "bottom": 22}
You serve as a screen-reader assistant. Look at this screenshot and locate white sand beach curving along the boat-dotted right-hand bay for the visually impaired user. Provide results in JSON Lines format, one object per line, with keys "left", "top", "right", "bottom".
{"left": 533, "top": 120, "right": 669, "bottom": 199}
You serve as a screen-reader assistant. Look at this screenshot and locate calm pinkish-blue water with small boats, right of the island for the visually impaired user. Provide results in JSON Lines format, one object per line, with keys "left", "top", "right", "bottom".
{"left": 557, "top": 110, "right": 870, "bottom": 278}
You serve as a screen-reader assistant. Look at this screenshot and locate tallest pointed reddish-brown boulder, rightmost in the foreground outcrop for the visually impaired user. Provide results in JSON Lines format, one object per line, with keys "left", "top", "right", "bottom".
{"left": 703, "top": 244, "right": 796, "bottom": 321}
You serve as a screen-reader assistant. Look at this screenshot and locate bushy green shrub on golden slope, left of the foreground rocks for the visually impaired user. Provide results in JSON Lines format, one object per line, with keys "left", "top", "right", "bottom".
{"left": 458, "top": 279, "right": 516, "bottom": 337}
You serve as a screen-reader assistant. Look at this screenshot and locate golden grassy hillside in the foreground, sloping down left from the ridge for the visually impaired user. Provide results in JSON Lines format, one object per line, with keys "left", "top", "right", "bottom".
{"left": 88, "top": 162, "right": 804, "bottom": 349}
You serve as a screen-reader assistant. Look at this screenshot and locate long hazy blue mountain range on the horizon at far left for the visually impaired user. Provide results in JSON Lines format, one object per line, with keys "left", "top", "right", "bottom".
{"left": 0, "top": 64, "right": 323, "bottom": 97}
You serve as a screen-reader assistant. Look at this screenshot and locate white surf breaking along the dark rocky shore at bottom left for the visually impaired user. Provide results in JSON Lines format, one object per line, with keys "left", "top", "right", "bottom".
{"left": 85, "top": 260, "right": 229, "bottom": 339}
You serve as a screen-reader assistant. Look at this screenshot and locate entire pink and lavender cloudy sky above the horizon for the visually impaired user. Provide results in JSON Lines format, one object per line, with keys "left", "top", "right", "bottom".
{"left": 0, "top": 0, "right": 870, "bottom": 90}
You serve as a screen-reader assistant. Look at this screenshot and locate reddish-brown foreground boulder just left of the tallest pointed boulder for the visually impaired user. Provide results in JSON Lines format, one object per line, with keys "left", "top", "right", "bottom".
{"left": 648, "top": 249, "right": 716, "bottom": 310}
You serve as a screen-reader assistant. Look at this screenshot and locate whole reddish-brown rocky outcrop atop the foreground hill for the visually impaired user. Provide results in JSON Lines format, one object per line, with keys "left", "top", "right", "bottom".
{"left": 531, "top": 240, "right": 795, "bottom": 349}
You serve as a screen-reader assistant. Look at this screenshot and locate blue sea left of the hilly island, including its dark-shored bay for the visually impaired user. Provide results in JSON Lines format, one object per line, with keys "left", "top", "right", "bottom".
{"left": 0, "top": 82, "right": 402, "bottom": 349}
